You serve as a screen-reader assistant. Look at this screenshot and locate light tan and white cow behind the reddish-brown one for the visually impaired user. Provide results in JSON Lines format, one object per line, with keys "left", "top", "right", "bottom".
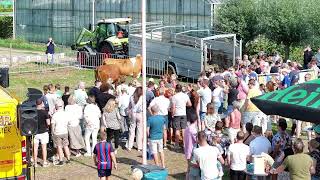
{"left": 103, "top": 54, "right": 142, "bottom": 78}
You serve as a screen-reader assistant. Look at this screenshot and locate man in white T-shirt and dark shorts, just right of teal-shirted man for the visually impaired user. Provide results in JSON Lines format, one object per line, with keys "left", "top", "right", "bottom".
{"left": 171, "top": 84, "right": 192, "bottom": 148}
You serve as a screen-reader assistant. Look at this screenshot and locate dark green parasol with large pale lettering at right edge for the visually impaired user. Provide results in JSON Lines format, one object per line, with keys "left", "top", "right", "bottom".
{"left": 251, "top": 79, "right": 320, "bottom": 124}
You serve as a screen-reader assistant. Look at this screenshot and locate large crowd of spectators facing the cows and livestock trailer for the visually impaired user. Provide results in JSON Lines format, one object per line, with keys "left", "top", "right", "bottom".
{"left": 33, "top": 48, "right": 320, "bottom": 180}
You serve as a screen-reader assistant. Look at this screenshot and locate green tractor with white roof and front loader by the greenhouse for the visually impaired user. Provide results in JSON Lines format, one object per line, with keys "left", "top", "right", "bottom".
{"left": 71, "top": 18, "right": 132, "bottom": 66}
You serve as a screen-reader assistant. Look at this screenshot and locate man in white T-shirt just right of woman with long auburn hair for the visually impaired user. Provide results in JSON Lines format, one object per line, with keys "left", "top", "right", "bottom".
{"left": 197, "top": 79, "right": 212, "bottom": 130}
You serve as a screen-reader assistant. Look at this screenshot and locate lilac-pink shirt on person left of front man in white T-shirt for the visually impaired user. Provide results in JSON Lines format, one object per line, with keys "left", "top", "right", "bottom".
{"left": 183, "top": 124, "right": 198, "bottom": 159}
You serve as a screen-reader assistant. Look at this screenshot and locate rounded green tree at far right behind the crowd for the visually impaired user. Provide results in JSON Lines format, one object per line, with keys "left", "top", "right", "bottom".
{"left": 259, "top": 0, "right": 314, "bottom": 59}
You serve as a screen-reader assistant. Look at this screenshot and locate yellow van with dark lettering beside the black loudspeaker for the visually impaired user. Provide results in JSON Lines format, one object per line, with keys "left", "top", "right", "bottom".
{"left": 0, "top": 88, "right": 27, "bottom": 180}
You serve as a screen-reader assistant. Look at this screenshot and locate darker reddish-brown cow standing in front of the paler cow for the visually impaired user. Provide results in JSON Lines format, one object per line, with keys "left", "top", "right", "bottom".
{"left": 95, "top": 64, "right": 121, "bottom": 84}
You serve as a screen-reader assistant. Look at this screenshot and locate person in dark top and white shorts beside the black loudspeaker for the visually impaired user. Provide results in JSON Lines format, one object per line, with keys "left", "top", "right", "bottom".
{"left": 33, "top": 99, "right": 50, "bottom": 167}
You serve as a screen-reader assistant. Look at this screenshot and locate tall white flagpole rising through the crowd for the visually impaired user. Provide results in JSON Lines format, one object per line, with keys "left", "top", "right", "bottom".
{"left": 141, "top": 0, "right": 147, "bottom": 165}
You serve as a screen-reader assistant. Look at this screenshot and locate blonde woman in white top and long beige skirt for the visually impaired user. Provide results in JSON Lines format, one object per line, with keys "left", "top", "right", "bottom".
{"left": 65, "top": 95, "right": 85, "bottom": 157}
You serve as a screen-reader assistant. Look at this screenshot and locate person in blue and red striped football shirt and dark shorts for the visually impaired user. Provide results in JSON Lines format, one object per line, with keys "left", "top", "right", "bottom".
{"left": 93, "top": 131, "right": 118, "bottom": 180}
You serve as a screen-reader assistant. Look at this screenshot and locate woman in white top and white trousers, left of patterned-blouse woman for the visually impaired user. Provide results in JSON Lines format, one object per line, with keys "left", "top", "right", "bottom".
{"left": 83, "top": 96, "right": 101, "bottom": 156}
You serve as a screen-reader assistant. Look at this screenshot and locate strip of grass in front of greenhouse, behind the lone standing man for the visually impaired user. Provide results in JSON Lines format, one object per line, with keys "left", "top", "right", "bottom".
{"left": 0, "top": 38, "right": 74, "bottom": 54}
